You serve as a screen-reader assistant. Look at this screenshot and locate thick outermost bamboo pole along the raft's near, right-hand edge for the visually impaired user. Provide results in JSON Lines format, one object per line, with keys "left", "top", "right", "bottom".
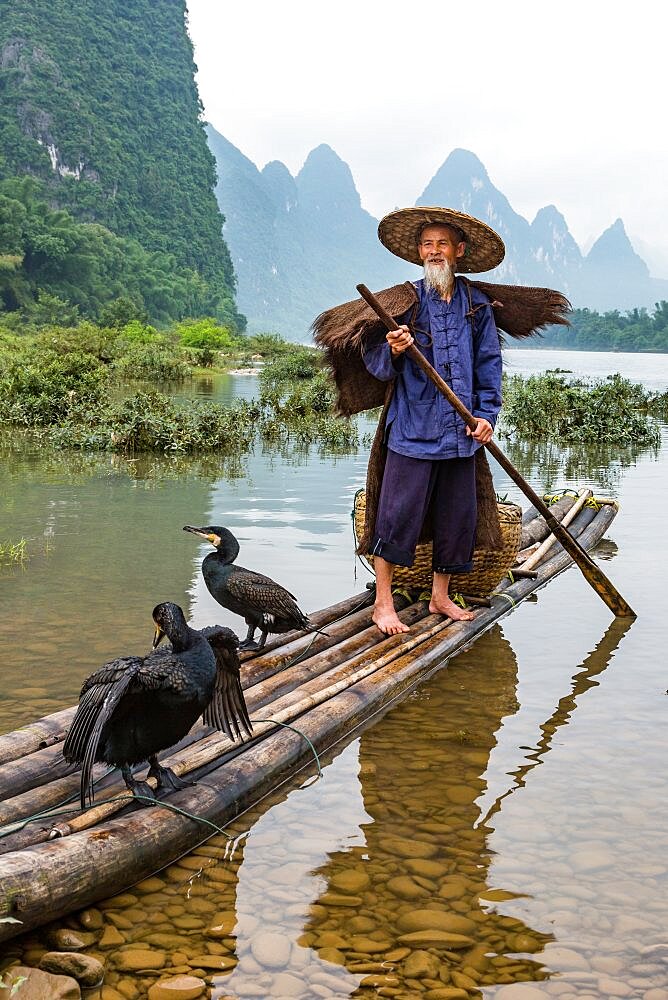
{"left": 0, "top": 509, "right": 616, "bottom": 940}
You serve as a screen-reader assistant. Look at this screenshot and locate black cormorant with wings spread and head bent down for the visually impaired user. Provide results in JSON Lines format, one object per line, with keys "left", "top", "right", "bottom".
{"left": 63, "top": 603, "right": 251, "bottom": 809}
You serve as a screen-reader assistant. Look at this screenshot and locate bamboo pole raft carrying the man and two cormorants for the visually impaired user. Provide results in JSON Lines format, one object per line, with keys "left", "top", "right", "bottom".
{"left": 0, "top": 498, "right": 617, "bottom": 939}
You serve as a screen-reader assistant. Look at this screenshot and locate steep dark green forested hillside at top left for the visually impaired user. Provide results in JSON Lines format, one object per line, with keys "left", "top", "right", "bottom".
{"left": 0, "top": 0, "right": 243, "bottom": 326}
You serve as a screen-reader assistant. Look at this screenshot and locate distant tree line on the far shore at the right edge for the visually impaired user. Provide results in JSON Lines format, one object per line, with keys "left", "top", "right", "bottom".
{"left": 524, "top": 301, "right": 668, "bottom": 354}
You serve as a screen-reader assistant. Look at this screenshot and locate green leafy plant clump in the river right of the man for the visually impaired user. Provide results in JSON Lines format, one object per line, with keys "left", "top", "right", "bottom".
{"left": 502, "top": 372, "right": 661, "bottom": 447}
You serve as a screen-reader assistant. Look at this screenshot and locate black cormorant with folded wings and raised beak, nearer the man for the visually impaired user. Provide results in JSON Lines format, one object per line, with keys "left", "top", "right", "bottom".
{"left": 183, "top": 524, "right": 311, "bottom": 649}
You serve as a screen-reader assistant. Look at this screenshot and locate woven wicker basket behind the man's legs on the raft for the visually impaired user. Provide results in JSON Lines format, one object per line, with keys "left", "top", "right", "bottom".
{"left": 353, "top": 490, "right": 522, "bottom": 597}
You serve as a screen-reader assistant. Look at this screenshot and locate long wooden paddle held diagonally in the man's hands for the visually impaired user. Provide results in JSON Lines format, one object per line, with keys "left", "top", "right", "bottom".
{"left": 357, "top": 285, "right": 637, "bottom": 618}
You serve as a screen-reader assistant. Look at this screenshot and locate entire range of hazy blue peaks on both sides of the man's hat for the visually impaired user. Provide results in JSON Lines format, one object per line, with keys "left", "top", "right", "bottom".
{"left": 207, "top": 127, "right": 668, "bottom": 339}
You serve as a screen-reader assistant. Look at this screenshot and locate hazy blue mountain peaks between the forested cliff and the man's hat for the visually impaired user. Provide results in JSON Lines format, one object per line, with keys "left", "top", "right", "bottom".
{"left": 208, "top": 128, "right": 410, "bottom": 332}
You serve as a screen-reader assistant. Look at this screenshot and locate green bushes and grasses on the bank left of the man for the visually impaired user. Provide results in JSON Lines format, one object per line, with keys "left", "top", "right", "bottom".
{"left": 0, "top": 320, "right": 359, "bottom": 455}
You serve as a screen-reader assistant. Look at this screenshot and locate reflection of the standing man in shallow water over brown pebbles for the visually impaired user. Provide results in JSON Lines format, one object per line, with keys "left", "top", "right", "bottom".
{"left": 306, "top": 626, "right": 551, "bottom": 996}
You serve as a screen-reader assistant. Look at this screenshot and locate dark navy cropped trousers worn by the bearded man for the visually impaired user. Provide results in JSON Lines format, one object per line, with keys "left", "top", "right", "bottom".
{"left": 370, "top": 450, "right": 477, "bottom": 573}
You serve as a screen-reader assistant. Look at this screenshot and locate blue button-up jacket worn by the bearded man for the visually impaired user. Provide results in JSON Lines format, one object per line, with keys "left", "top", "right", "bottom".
{"left": 364, "top": 279, "right": 501, "bottom": 459}
